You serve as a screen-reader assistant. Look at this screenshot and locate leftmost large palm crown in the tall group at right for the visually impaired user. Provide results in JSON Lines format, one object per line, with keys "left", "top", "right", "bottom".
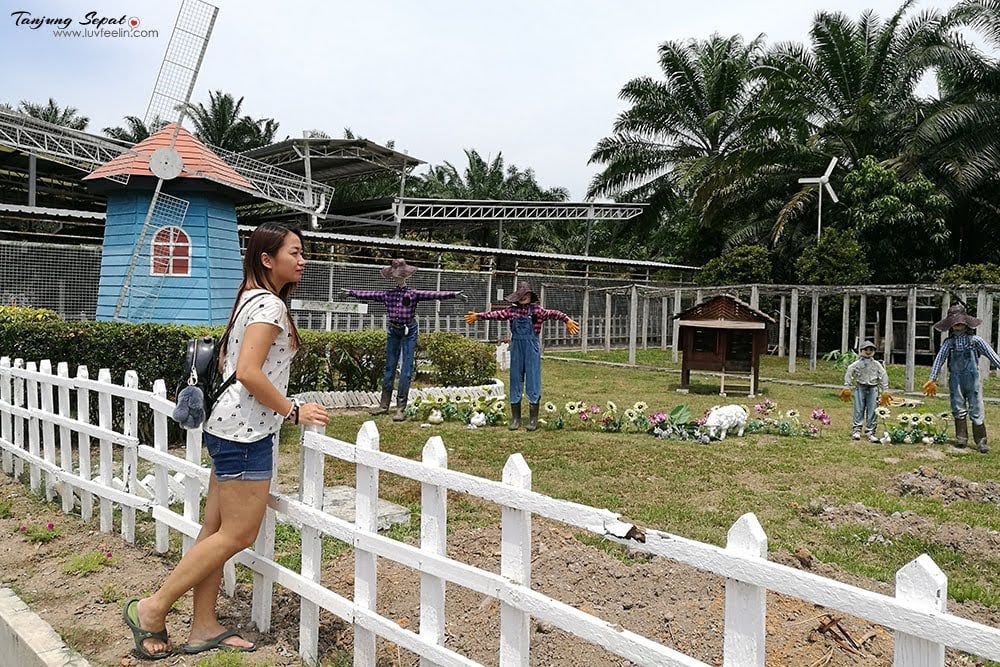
{"left": 587, "top": 34, "right": 763, "bottom": 229}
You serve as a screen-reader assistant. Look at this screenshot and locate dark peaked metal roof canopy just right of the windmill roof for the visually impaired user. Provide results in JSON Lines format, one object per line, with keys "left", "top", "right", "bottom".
{"left": 241, "top": 137, "right": 424, "bottom": 183}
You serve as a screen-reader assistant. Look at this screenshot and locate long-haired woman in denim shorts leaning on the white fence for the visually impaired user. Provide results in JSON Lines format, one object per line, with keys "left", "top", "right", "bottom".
{"left": 123, "top": 223, "right": 327, "bottom": 660}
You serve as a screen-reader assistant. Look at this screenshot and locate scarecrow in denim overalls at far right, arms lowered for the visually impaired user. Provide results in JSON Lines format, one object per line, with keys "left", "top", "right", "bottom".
{"left": 924, "top": 303, "right": 1000, "bottom": 454}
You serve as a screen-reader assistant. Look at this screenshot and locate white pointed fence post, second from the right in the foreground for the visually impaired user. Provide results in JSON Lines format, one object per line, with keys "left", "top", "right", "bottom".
{"left": 722, "top": 512, "right": 767, "bottom": 667}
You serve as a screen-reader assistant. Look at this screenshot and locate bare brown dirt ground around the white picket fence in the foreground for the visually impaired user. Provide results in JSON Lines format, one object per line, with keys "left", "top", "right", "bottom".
{"left": 0, "top": 475, "right": 998, "bottom": 667}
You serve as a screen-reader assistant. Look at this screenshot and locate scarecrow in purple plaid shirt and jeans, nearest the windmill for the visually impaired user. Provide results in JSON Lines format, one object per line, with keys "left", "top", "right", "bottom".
{"left": 347, "top": 259, "right": 463, "bottom": 421}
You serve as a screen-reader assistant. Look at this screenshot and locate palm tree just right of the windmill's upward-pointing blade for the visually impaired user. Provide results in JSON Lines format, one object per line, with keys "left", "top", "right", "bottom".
{"left": 188, "top": 90, "right": 278, "bottom": 152}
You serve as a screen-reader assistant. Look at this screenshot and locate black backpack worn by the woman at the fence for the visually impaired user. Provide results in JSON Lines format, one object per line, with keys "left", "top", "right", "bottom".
{"left": 172, "top": 294, "right": 265, "bottom": 429}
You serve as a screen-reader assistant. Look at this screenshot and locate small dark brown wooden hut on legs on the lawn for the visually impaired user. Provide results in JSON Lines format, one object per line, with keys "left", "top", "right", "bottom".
{"left": 674, "top": 294, "right": 775, "bottom": 396}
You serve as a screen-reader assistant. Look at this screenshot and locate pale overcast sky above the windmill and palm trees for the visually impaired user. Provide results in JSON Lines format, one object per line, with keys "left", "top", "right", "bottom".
{"left": 0, "top": 0, "right": 953, "bottom": 199}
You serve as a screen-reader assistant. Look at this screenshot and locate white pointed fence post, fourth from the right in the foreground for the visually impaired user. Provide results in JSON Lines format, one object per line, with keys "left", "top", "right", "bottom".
{"left": 420, "top": 435, "right": 448, "bottom": 667}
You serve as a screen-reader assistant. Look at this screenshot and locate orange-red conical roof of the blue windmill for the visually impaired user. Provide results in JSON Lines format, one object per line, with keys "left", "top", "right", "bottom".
{"left": 83, "top": 123, "right": 256, "bottom": 190}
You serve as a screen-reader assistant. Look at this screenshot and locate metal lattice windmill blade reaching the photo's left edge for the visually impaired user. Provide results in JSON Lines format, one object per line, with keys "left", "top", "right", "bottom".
{"left": 0, "top": 111, "right": 129, "bottom": 185}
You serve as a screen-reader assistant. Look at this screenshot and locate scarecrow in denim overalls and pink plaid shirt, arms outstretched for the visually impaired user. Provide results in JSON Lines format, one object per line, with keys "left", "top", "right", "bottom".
{"left": 465, "top": 282, "right": 580, "bottom": 431}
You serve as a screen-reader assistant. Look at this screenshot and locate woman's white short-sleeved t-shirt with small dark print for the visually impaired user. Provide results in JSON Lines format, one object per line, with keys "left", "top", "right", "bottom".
{"left": 205, "top": 289, "right": 295, "bottom": 443}
